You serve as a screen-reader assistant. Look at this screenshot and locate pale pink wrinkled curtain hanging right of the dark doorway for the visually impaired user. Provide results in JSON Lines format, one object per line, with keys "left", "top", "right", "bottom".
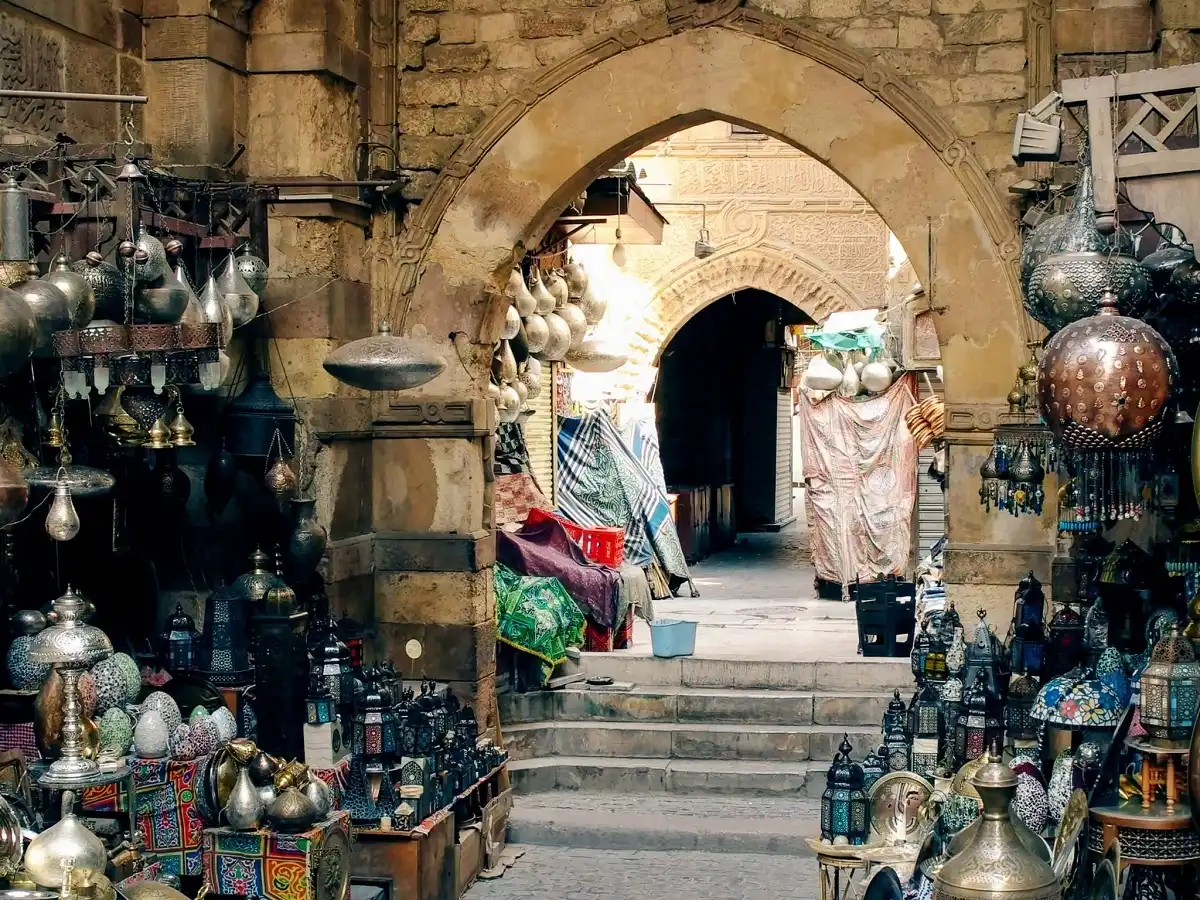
{"left": 799, "top": 374, "right": 917, "bottom": 595}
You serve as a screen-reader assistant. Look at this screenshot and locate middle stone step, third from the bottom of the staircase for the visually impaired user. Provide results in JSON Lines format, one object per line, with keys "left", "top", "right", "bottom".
{"left": 504, "top": 721, "right": 880, "bottom": 762}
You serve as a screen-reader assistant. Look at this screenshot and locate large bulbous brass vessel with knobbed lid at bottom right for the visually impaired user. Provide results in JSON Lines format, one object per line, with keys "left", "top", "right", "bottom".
{"left": 934, "top": 745, "right": 1062, "bottom": 900}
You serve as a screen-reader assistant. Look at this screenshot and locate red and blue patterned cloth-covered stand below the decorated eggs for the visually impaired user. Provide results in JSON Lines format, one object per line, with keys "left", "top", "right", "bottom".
{"left": 83, "top": 760, "right": 204, "bottom": 875}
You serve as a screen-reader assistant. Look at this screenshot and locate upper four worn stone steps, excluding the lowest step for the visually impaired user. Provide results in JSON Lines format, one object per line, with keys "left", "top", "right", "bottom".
{"left": 500, "top": 654, "right": 912, "bottom": 799}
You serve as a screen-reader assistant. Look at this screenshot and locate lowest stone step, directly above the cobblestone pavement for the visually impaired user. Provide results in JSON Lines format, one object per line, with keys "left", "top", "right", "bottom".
{"left": 509, "top": 791, "right": 821, "bottom": 857}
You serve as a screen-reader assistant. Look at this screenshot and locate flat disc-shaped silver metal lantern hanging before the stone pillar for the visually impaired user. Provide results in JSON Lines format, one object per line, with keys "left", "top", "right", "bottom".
{"left": 324, "top": 323, "right": 446, "bottom": 391}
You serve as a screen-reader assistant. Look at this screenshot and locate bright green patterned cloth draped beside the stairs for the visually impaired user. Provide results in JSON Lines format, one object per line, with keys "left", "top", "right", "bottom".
{"left": 493, "top": 563, "right": 583, "bottom": 667}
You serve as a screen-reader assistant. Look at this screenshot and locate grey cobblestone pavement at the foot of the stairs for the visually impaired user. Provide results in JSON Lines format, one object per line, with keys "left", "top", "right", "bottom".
{"left": 467, "top": 847, "right": 821, "bottom": 900}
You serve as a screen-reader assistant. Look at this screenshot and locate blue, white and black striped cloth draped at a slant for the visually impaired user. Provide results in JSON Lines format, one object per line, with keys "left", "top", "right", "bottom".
{"left": 554, "top": 413, "right": 690, "bottom": 581}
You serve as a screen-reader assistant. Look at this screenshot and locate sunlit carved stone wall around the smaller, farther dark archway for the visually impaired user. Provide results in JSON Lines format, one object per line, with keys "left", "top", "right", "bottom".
{"left": 575, "top": 121, "right": 888, "bottom": 400}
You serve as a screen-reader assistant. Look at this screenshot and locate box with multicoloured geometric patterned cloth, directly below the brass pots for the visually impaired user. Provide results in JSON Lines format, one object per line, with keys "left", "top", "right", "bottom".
{"left": 204, "top": 812, "right": 350, "bottom": 900}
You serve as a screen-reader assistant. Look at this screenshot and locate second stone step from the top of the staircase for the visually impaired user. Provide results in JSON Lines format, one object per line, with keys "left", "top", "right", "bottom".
{"left": 499, "top": 685, "right": 892, "bottom": 726}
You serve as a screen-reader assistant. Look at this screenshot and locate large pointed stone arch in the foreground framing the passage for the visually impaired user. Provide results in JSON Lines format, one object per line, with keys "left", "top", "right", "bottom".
{"left": 396, "top": 0, "right": 1025, "bottom": 415}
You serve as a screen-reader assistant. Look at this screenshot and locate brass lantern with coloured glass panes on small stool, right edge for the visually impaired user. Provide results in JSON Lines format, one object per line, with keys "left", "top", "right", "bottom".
{"left": 1141, "top": 625, "right": 1200, "bottom": 748}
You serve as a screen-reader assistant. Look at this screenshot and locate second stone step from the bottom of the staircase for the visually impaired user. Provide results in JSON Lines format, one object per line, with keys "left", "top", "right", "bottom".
{"left": 509, "top": 756, "right": 829, "bottom": 811}
